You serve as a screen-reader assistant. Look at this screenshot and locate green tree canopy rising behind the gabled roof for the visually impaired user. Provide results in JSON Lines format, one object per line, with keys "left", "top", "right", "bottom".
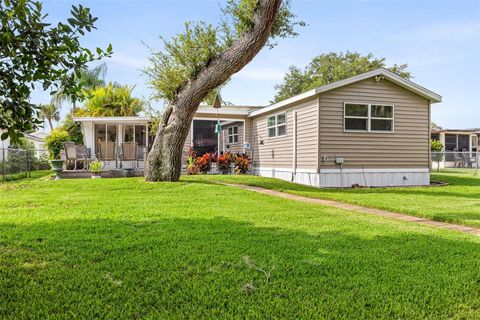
{"left": 274, "top": 51, "right": 411, "bottom": 102}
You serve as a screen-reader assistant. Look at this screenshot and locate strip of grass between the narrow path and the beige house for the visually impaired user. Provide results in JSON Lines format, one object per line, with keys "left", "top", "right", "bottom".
{"left": 195, "top": 169, "right": 480, "bottom": 227}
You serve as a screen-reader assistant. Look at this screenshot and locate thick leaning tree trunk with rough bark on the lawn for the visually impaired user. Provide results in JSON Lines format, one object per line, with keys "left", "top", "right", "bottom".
{"left": 146, "top": 0, "right": 282, "bottom": 181}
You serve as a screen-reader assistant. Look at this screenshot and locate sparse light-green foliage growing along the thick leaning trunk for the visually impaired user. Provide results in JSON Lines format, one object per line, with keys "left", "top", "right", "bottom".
{"left": 144, "top": 0, "right": 305, "bottom": 101}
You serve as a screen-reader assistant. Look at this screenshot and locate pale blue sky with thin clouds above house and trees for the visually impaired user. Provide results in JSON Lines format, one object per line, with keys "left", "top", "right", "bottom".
{"left": 32, "top": 0, "right": 480, "bottom": 128}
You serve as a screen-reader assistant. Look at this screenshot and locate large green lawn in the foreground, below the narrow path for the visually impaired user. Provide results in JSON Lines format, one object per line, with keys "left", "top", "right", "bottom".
{"left": 0, "top": 175, "right": 480, "bottom": 319}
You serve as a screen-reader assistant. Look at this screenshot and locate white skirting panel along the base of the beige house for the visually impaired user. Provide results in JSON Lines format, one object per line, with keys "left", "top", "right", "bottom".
{"left": 253, "top": 168, "right": 430, "bottom": 188}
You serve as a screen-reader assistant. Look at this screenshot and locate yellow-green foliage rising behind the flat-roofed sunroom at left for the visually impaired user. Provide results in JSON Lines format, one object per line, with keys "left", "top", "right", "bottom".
{"left": 75, "top": 83, "right": 144, "bottom": 117}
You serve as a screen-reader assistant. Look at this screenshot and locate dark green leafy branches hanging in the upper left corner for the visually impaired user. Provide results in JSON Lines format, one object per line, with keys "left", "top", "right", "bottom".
{"left": 0, "top": 0, "right": 112, "bottom": 141}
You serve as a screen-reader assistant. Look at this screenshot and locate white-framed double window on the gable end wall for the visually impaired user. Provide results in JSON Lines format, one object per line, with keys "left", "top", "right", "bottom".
{"left": 343, "top": 103, "right": 394, "bottom": 132}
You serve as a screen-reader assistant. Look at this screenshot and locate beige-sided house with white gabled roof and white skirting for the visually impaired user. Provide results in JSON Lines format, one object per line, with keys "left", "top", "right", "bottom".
{"left": 184, "top": 68, "right": 442, "bottom": 187}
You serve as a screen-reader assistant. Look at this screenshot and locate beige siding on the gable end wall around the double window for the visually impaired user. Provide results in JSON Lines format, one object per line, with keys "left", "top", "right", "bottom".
{"left": 319, "top": 78, "right": 430, "bottom": 168}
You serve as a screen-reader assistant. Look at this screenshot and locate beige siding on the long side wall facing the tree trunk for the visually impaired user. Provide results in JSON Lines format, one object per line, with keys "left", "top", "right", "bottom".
{"left": 252, "top": 98, "right": 318, "bottom": 170}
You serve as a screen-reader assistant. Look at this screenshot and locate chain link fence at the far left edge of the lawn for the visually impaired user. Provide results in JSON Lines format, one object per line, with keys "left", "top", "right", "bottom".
{"left": 0, "top": 148, "right": 51, "bottom": 181}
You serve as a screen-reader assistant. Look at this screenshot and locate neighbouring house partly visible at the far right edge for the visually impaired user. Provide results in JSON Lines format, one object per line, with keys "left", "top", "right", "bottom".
{"left": 431, "top": 128, "right": 480, "bottom": 168}
